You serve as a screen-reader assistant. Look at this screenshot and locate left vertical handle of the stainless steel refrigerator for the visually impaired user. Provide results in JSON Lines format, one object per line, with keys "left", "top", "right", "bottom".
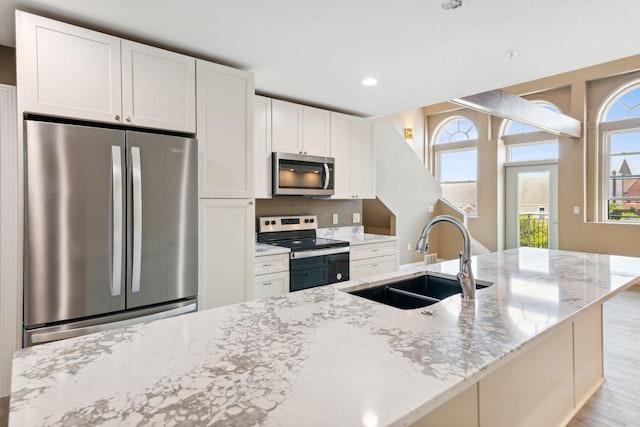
{"left": 111, "top": 146, "right": 123, "bottom": 297}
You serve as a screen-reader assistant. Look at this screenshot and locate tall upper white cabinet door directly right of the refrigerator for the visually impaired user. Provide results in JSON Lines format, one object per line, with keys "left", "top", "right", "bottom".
{"left": 197, "top": 60, "right": 254, "bottom": 199}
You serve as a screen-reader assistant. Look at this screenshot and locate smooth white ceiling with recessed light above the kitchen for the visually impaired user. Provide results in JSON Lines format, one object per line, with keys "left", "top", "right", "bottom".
{"left": 0, "top": 0, "right": 640, "bottom": 116}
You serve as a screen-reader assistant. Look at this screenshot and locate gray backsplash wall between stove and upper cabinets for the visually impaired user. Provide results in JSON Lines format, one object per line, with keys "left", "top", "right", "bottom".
{"left": 256, "top": 197, "right": 362, "bottom": 228}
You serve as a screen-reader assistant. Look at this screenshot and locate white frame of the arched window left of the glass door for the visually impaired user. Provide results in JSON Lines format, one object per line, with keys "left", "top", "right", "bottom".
{"left": 431, "top": 115, "right": 479, "bottom": 218}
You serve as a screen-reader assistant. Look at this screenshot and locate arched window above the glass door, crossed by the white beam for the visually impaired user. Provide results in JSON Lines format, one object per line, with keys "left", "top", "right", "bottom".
{"left": 502, "top": 100, "right": 561, "bottom": 163}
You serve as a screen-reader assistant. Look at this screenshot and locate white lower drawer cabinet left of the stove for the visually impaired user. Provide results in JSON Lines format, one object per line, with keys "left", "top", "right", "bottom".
{"left": 251, "top": 253, "right": 289, "bottom": 299}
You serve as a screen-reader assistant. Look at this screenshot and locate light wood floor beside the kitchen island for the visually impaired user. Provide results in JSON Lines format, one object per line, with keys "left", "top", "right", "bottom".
{"left": 0, "top": 291, "right": 640, "bottom": 427}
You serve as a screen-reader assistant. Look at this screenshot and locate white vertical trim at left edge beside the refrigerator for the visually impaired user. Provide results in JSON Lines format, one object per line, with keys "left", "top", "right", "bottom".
{"left": 0, "top": 85, "right": 21, "bottom": 397}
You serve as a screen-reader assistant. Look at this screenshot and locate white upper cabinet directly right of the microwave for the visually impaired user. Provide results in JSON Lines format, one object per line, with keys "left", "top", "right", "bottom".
{"left": 331, "top": 113, "right": 376, "bottom": 199}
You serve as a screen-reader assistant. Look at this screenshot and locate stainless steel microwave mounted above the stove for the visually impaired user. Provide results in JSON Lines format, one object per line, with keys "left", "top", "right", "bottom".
{"left": 272, "top": 153, "right": 335, "bottom": 196}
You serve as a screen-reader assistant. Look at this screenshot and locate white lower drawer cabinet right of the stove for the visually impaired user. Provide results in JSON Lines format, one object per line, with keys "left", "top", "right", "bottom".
{"left": 349, "top": 240, "right": 399, "bottom": 280}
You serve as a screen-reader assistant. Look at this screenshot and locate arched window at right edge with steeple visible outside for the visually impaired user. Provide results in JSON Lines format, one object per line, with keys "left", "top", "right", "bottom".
{"left": 598, "top": 81, "right": 640, "bottom": 221}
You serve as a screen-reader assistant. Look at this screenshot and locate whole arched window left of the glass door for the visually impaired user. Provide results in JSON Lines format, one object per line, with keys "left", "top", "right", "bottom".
{"left": 433, "top": 117, "right": 478, "bottom": 215}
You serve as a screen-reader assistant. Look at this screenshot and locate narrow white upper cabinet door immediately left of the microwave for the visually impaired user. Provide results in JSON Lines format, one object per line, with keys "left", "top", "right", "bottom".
{"left": 253, "top": 96, "right": 272, "bottom": 199}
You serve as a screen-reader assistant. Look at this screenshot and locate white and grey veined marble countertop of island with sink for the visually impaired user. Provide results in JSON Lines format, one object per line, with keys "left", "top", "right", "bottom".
{"left": 9, "top": 248, "right": 640, "bottom": 427}
